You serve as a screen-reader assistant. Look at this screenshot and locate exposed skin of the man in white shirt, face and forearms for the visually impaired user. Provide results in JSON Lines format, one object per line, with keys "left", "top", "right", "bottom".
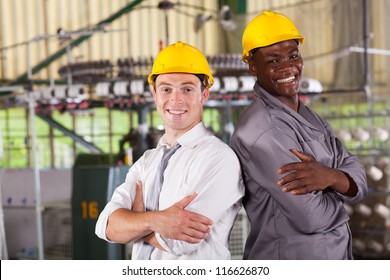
{"left": 106, "top": 73, "right": 212, "bottom": 250}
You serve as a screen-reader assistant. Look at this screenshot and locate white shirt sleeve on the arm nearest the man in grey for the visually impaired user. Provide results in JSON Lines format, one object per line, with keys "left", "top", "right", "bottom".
{"left": 156, "top": 148, "right": 244, "bottom": 255}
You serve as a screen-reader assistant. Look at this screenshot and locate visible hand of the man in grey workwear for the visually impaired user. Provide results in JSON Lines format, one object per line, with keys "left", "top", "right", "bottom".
{"left": 277, "top": 149, "right": 336, "bottom": 195}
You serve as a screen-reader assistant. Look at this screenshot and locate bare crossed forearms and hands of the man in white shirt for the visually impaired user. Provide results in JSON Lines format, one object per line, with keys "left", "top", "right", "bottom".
{"left": 106, "top": 183, "right": 212, "bottom": 244}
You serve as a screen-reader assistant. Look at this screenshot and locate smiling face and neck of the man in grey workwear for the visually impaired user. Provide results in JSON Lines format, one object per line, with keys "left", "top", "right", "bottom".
{"left": 249, "top": 40, "right": 303, "bottom": 110}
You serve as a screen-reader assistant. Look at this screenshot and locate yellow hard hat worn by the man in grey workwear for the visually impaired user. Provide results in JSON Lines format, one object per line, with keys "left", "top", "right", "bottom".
{"left": 242, "top": 11, "right": 304, "bottom": 63}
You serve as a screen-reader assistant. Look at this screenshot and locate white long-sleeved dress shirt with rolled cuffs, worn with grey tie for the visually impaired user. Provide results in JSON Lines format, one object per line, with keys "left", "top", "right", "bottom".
{"left": 96, "top": 122, "right": 244, "bottom": 260}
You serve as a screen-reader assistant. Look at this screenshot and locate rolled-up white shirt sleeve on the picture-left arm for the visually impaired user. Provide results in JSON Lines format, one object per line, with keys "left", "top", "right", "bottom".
{"left": 95, "top": 157, "right": 143, "bottom": 242}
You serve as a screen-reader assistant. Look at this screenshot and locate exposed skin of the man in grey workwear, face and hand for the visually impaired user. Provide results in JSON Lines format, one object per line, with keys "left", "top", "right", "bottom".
{"left": 249, "top": 40, "right": 358, "bottom": 197}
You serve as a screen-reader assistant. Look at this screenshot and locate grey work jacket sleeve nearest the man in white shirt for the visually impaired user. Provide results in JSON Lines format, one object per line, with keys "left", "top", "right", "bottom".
{"left": 241, "top": 128, "right": 346, "bottom": 233}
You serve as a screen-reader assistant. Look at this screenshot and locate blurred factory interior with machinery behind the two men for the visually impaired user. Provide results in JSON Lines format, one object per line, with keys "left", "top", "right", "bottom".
{"left": 0, "top": 0, "right": 390, "bottom": 260}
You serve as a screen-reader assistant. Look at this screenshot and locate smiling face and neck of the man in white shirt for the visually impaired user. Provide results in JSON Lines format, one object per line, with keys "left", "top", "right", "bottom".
{"left": 152, "top": 73, "right": 209, "bottom": 144}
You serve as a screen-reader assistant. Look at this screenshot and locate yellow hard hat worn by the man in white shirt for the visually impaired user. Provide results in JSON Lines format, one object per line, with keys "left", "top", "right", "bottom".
{"left": 148, "top": 41, "right": 214, "bottom": 88}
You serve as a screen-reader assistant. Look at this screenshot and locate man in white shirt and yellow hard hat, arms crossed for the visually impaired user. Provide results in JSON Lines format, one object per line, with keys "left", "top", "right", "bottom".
{"left": 96, "top": 41, "right": 244, "bottom": 260}
